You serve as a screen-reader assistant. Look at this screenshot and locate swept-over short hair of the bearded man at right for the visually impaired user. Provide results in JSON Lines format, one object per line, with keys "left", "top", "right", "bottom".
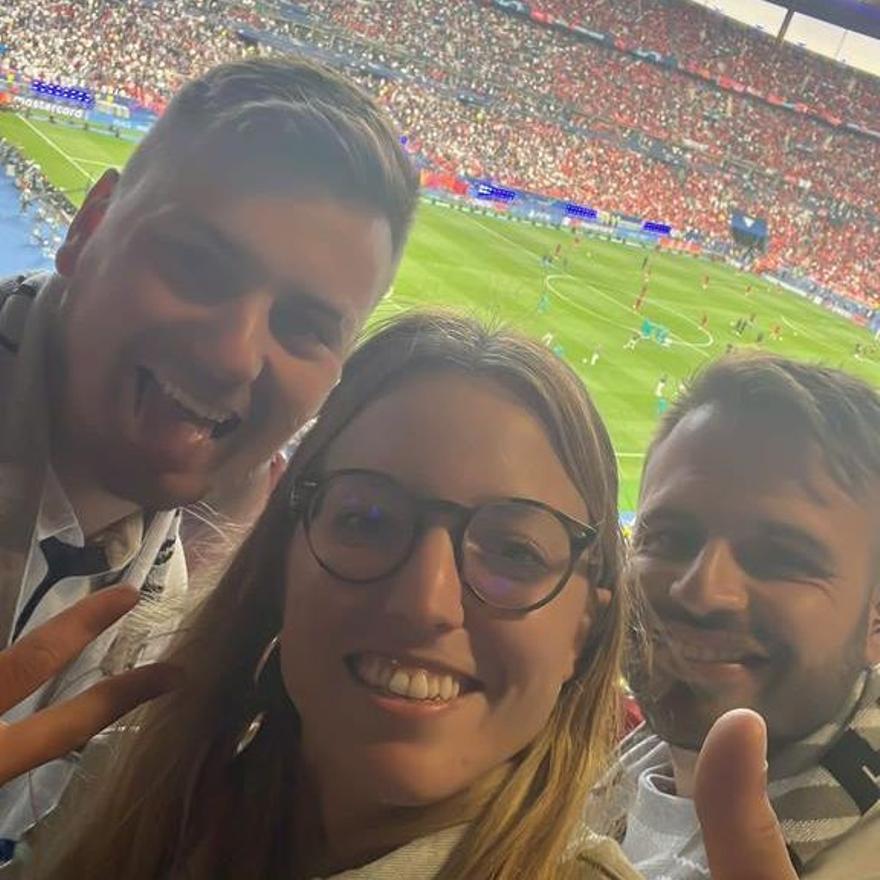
{"left": 645, "top": 355, "right": 880, "bottom": 496}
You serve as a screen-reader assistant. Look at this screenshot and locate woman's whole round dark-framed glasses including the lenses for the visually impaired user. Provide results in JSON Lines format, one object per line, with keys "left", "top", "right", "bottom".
{"left": 291, "top": 469, "right": 598, "bottom": 613}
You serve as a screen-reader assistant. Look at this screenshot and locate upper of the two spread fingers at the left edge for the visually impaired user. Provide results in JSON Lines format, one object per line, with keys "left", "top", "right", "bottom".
{"left": 0, "top": 586, "right": 139, "bottom": 712}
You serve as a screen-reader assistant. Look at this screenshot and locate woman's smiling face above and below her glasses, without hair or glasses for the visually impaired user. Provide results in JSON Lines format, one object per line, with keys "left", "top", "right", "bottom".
{"left": 281, "top": 371, "right": 594, "bottom": 806}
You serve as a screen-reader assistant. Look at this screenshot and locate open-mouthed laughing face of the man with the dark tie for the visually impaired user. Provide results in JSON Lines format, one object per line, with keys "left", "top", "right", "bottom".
{"left": 54, "top": 172, "right": 393, "bottom": 508}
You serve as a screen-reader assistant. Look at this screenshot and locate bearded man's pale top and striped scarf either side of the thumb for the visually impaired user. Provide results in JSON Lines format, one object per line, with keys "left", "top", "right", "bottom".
{"left": 593, "top": 666, "right": 880, "bottom": 880}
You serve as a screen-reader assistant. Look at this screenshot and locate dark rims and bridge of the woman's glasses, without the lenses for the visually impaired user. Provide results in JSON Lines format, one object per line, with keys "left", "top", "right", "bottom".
{"left": 290, "top": 468, "right": 599, "bottom": 615}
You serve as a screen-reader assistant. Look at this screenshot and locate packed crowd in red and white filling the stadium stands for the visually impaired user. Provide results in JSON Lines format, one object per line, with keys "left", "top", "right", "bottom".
{"left": 0, "top": 0, "right": 880, "bottom": 299}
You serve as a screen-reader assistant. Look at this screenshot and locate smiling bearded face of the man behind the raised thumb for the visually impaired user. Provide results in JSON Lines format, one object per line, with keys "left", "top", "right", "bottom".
{"left": 632, "top": 404, "right": 880, "bottom": 748}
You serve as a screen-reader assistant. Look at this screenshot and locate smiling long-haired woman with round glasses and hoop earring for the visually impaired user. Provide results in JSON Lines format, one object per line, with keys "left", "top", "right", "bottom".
{"left": 27, "top": 315, "right": 634, "bottom": 880}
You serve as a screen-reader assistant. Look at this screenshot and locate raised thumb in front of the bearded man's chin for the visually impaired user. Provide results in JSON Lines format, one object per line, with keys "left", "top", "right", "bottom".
{"left": 694, "top": 709, "right": 797, "bottom": 880}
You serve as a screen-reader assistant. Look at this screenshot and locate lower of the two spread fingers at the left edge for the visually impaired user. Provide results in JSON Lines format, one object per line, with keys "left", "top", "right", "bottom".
{"left": 0, "top": 663, "right": 181, "bottom": 784}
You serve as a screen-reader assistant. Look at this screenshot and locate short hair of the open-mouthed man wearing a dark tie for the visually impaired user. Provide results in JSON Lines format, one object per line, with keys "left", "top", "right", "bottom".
{"left": 119, "top": 57, "right": 418, "bottom": 257}
